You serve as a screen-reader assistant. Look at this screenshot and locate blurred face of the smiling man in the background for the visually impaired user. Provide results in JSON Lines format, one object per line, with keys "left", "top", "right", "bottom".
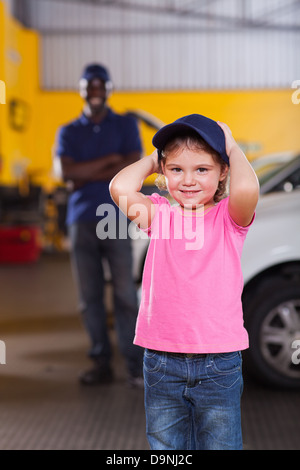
{"left": 80, "top": 78, "right": 109, "bottom": 114}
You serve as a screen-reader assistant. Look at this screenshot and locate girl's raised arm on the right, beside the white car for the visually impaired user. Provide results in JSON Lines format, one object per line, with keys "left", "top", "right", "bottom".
{"left": 218, "top": 122, "right": 259, "bottom": 227}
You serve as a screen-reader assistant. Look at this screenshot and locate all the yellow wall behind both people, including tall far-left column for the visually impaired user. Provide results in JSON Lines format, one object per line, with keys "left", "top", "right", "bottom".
{"left": 0, "top": 2, "right": 300, "bottom": 191}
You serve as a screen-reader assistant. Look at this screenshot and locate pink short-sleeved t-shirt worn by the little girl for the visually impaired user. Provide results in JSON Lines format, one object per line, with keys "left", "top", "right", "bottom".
{"left": 134, "top": 193, "right": 254, "bottom": 353}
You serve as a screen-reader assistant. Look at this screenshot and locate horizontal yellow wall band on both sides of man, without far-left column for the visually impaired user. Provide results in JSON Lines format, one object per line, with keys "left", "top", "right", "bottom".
{"left": 38, "top": 90, "right": 300, "bottom": 185}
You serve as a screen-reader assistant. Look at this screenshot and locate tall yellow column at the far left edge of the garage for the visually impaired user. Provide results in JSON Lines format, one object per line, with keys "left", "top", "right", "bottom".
{"left": 0, "top": 2, "right": 38, "bottom": 183}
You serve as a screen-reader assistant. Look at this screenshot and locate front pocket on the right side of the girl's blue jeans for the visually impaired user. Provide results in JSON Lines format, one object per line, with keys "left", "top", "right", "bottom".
{"left": 206, "top": 351, "right": 242, "bottom": 388}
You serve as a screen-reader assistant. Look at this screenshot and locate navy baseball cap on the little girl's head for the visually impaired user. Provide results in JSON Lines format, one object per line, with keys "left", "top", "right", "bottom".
{"left": 152, "top": 114, "right": 229, "bottom": 165}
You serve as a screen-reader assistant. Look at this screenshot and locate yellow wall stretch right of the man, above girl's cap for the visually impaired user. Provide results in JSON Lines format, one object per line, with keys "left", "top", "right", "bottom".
{"left": 111, "top": 90, "right": 300, "bottom": 159}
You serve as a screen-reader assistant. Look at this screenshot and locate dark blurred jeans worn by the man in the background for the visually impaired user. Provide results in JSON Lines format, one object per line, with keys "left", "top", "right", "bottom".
{"left": 69, "top": 222, "right": 143, "bottom": 376}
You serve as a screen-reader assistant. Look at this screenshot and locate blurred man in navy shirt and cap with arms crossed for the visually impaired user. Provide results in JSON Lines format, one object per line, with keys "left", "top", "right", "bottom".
{"left": 57, "top": 64, "right": 142, "bottom": 386}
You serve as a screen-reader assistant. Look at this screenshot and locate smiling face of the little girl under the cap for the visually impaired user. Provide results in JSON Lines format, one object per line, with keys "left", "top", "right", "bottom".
{"left": 163, "top": 147, "right": 228, "bottom": 209}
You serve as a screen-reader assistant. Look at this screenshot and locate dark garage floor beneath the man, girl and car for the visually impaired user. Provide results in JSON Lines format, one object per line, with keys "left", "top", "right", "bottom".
{"left": 0, "top": 254, "right": 300, "bottom": 450}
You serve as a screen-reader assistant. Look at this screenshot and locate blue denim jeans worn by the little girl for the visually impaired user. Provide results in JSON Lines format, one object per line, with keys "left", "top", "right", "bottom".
{"left": 144, "top": 349, "right": 243, "bottom": 450}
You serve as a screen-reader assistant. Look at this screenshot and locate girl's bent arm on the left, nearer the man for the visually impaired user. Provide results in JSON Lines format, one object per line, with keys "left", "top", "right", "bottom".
{"left": 109, "top": 150, "right": 159, "bottom": 229}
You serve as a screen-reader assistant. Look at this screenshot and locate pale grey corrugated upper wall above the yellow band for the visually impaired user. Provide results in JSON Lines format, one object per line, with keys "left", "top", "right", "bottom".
{"left": 10, "top": 0, "right": 300, "bottom": 90}
